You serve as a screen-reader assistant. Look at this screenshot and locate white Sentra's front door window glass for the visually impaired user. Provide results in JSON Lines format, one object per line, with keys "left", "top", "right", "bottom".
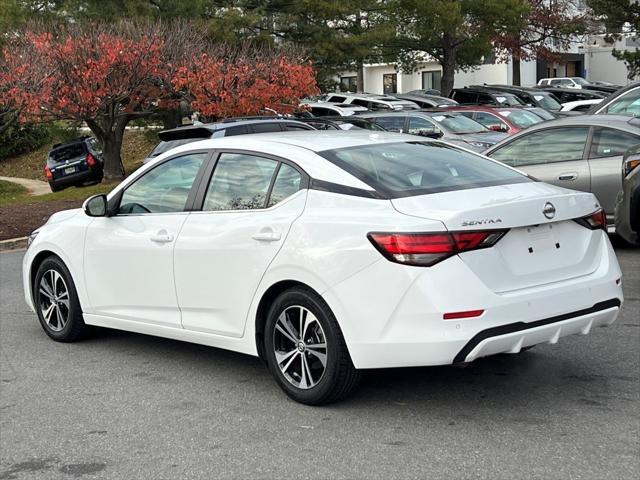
{"left": 118, "top": 153, "right": 208, "bottom": 215}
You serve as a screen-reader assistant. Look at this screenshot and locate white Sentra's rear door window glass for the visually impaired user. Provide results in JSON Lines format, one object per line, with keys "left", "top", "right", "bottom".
{"left": 203, "top": 153, "right": 278, "bottom": 210}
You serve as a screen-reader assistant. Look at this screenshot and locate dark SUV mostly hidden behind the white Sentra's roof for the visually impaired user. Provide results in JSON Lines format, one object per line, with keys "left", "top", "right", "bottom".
{"left": 143, "top": 117, "right": 316, "bottom": 163}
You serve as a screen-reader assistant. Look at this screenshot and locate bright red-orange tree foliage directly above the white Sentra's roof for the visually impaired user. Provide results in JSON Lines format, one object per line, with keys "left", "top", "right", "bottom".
{"left": 173, "top": 45, "right": 319, "bottom": 118}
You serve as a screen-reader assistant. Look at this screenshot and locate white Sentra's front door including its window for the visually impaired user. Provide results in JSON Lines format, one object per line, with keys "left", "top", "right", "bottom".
{"left": 84, "top": 153, "right": 208, "bottom": 327}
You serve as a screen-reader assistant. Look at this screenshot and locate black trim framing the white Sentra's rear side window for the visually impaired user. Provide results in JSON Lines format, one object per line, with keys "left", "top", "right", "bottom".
{"left": 191, "top": 148, "right": 311, "bottom": 213}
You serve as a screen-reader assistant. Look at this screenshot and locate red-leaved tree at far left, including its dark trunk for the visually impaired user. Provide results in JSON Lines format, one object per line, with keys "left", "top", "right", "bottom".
{"left": 0, "top": 24, "right": 178, "bottom": 178}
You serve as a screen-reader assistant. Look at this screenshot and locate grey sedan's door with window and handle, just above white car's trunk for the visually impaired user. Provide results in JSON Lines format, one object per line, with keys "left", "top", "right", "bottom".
{"left": 487, "top": 126, "right": 591, "bottom": 192}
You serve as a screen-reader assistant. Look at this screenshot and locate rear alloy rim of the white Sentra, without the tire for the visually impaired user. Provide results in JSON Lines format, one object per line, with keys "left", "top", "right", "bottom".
{"left": 273, "top": 305, "right": 327, "bottom": 390}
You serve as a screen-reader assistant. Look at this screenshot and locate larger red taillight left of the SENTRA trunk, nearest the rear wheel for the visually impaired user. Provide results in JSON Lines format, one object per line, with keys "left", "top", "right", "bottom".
{"left": 367, "top": 230, "right": 507, "bottom": 267}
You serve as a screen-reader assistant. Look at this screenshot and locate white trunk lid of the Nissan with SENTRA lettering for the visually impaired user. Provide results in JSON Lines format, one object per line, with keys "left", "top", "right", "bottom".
{"left": 392, "top": 182, "right": 603, "bottom": 293}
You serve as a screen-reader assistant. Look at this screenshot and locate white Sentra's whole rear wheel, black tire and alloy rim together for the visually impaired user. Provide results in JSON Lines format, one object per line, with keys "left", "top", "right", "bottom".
{"left": 264, "top": 287, "right": 360, "bottom": 405}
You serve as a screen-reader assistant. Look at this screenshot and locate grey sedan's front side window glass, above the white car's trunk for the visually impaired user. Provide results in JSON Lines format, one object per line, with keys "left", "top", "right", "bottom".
{"left": 489, "top": 127, "right": 589, "bottom": 167}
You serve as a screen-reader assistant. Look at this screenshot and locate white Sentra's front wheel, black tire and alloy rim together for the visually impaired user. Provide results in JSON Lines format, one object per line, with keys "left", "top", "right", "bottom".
{"left": 33, "top": 256, "right": 88, "bottom": 342}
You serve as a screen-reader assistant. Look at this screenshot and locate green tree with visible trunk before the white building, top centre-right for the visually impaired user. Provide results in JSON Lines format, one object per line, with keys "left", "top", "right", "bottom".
{"left": 388, "top": 0, "right": 527, "bottom": 95}
